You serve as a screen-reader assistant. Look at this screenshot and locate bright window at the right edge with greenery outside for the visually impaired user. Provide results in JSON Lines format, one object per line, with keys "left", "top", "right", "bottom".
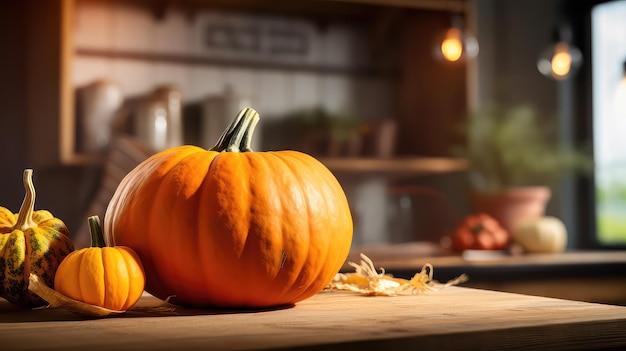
{"left": 591, "top": 0, "right": 626, "bottom": 245}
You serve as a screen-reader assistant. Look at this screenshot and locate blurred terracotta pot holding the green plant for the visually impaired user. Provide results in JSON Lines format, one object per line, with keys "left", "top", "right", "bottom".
{"left": 471, "top": 186, "right": 551, "bottom": 233}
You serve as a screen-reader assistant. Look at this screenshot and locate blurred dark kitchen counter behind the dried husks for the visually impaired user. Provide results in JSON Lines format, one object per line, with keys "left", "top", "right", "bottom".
{"left": 342, "top": 242, "right": 626, "bottom": 305}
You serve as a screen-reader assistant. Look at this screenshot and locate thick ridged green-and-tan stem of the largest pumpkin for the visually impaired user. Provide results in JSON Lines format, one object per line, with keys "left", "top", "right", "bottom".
{"left": 209, "top": 107, "right": 259, "bottom": 152}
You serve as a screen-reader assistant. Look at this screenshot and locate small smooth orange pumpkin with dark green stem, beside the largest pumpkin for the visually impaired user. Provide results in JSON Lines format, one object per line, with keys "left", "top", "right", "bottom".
{"left": 54, "top": 216, "right": 145, "bottom": 311}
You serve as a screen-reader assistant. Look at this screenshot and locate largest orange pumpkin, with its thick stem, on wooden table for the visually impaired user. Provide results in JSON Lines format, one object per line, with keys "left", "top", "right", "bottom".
{"left": 104, "top": 108, "right": 353, "bottom": 308}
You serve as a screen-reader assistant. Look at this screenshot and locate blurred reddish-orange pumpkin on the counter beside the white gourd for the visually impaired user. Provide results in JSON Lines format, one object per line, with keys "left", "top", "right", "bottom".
{"left": 452, "top": 213, "right": 510, "bottom": 251}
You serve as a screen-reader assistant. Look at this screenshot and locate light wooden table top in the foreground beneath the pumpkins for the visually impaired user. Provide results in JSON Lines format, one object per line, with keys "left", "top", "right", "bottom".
{"left": 0, "top": 286, "right": 626, "bottom": 351}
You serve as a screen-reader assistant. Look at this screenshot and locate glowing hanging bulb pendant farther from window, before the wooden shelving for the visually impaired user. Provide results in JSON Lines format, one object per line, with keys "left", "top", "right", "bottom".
{"left": 433, "top": 13, "right": 479, "bottom": 62}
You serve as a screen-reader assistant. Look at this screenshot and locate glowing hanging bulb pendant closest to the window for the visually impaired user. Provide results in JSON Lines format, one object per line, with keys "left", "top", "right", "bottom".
{"left": 537, "top": 26, "right": 583, "bottom": 81}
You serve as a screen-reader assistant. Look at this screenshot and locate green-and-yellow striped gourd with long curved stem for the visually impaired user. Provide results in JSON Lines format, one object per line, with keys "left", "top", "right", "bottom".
{"left": 0, "top": 169, "right": 74, "bottom": 307}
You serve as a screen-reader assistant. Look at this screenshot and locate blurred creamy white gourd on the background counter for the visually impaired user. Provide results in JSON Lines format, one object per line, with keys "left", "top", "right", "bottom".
{"left": 513, "top": 216, "right": 567, "bottom": 253}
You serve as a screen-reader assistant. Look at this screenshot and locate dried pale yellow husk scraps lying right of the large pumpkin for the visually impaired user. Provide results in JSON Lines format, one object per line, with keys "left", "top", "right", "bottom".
{"left": 326, "top": 254, "right": 468, "bottom": 296}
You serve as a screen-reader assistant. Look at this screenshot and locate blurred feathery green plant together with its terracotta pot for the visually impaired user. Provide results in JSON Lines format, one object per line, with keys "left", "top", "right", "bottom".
{"left": 454, "top": 105, "right": 591, "bottom": 231}
